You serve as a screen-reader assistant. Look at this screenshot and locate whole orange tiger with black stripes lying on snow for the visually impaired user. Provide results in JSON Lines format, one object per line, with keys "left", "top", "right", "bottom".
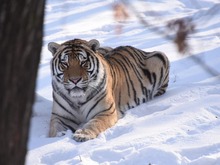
{"left": 48, "top": 39, "right": 170, "bottom": 142}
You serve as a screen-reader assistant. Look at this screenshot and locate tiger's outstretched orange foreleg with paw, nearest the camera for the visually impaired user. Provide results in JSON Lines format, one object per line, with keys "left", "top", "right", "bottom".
{"left": 73, "top": 109, "right": 118, "bottom": 142}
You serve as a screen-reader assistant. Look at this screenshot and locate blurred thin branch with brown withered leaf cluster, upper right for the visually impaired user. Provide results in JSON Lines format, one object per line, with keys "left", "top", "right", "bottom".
{"left": 116, "top": 0, "right": 220, "bottom": 76}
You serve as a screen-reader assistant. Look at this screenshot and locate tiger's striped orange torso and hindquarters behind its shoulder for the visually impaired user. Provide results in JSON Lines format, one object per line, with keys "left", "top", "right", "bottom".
{"left": 106, "top": 46, "right": 169, "bottom": 114}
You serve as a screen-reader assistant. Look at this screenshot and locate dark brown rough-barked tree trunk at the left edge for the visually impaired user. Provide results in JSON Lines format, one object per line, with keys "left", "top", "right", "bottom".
{"left": 0, "top": 0, "right": 45, "bottom": 165}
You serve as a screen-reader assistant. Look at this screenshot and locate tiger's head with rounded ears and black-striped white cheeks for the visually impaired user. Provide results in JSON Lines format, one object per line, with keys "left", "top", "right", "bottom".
{"left": 48, "top": 39, "right": 103, "bottom": 98}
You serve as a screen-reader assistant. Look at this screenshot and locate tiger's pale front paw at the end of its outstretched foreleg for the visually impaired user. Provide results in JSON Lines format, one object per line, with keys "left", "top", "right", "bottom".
{"left": 73, "top": 129, "right": 96, "bottom": 142}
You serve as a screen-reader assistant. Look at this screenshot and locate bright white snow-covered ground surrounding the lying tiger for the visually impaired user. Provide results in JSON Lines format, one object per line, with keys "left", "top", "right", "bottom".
{"left": 26, "top": 0, "right": 220, "bottom": 165}
